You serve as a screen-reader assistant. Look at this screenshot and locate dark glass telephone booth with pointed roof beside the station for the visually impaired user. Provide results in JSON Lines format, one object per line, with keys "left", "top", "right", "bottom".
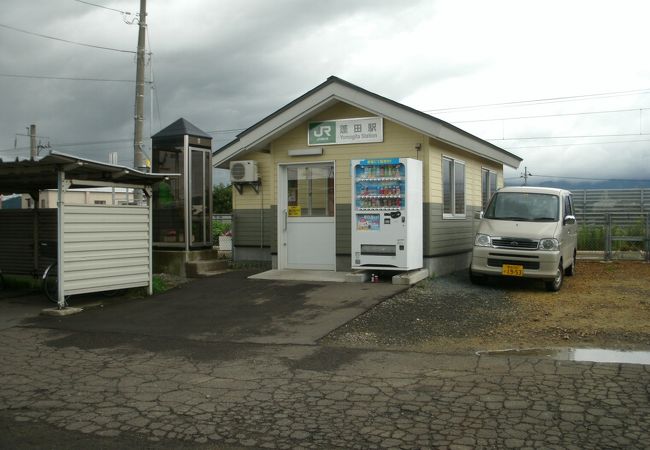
{"left": 151, "top": 118, "right": 212, "bottom": 252}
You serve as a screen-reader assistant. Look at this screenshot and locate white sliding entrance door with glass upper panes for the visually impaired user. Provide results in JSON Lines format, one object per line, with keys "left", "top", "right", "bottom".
{"left": 278, "top": 163, "right": 336, "bottom": 270}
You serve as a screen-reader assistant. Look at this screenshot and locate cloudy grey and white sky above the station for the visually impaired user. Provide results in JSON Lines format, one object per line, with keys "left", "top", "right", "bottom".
{"left": 0, "top": 0, "right": 650, "bottom": 184}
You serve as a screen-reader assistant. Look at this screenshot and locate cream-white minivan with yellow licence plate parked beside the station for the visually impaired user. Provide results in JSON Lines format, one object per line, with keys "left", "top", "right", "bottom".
{"left": 469, "top": 186, "right": 578, "bottom": 291}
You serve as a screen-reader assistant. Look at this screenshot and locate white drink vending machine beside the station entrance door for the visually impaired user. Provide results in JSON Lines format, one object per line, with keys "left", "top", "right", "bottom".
{"left": 351, "top": 158, "right": 423, "bottom": 270}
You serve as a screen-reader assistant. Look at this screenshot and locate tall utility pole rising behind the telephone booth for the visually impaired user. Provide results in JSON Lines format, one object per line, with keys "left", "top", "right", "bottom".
{"left": 133, "top": 0, "right": 147, "bottom": 203}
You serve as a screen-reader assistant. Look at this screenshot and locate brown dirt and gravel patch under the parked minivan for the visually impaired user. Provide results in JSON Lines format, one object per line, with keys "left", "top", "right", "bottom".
{"left": 322, "top": 261, "right": 650, "bottom": 352}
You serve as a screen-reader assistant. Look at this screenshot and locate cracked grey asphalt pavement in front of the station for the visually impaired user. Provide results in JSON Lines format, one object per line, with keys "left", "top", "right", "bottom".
{"left": 0, "top": 272, "right": 650, "bottom": 449}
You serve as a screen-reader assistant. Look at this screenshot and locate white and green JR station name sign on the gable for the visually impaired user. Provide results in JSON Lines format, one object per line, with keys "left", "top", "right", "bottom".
{"left": 307, "top": 117, "right": 384, "bottom": 145}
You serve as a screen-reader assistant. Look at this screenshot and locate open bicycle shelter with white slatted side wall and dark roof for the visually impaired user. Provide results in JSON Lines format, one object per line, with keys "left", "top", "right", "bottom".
{"left": 0, "top": 151, "right": 177, "bottom": 309}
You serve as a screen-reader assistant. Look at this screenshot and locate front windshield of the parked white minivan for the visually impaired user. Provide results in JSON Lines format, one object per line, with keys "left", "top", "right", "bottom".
{"left": 484, "top": 192, "right": 560, "bottom": 222}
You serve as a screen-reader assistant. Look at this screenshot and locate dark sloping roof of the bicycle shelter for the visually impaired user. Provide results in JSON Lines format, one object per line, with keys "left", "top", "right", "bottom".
{"left": 0, "top": 151, "right": 174, "bottom": 194}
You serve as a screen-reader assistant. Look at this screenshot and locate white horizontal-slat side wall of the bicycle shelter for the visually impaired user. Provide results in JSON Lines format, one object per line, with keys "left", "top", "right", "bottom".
{"left": 62, "top": 205, "right": 151, "bottom": 295}
